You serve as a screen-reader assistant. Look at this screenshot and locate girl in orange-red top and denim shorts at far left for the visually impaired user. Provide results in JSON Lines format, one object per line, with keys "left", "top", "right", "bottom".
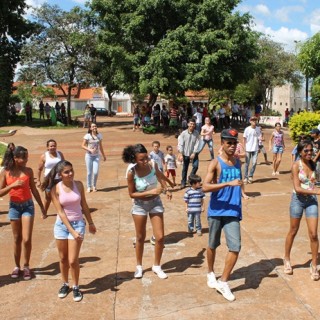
{"left": 0, "top": 146, "right": 47, "bottom": 280}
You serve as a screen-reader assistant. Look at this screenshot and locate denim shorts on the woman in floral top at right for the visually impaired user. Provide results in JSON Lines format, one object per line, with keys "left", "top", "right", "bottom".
{"left": 290, "top": 193, "right": 318, "bottom": 219}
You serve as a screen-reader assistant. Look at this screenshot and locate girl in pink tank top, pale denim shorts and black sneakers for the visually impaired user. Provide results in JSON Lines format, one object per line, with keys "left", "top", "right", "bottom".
{"left": 44, "top": 160, "right": 96, "bottom": 302}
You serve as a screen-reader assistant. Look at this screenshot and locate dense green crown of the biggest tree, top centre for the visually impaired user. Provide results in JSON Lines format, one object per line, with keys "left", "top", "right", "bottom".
{"left": 91, "top": 0, "right": 257, "bottom": 104}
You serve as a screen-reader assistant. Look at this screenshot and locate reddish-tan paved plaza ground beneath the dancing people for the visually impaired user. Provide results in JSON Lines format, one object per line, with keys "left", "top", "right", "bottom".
{"left": 0, "top": 118, "right": 320, "bottom": 320}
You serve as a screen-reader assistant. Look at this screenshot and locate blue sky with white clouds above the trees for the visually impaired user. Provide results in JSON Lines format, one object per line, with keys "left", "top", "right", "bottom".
{"left": 26, "top": 0, "right": 320, "bottom": 51}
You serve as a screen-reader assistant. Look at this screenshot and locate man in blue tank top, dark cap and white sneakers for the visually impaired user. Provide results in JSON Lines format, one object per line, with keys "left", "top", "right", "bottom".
{"left": 203, "top": 129, "right": 247, "bottom": 301}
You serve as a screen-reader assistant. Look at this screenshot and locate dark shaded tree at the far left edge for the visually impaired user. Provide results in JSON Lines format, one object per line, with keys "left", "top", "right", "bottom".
{"left": 0, "top": 0, "right": 34, "bottom": 125}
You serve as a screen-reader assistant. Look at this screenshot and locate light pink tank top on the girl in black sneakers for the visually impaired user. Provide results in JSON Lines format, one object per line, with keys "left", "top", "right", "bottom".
{"left": 57, "top": 181, "right": 83, "bottom": 221}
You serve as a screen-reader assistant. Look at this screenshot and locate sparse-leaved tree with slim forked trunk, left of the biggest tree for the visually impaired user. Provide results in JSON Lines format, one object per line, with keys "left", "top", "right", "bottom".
{"left": 22, "top": 4, "right": 95, "bottom": 123}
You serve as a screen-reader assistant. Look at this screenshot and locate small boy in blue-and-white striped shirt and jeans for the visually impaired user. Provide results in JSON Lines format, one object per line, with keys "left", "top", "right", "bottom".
{"left": 183, "top": 175, "right": 205, "bottom": 236}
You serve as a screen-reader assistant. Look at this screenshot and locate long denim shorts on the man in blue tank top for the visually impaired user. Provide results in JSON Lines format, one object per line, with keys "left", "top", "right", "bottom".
{"left": 208, "top": 217, "right": 241, "bottom": 252}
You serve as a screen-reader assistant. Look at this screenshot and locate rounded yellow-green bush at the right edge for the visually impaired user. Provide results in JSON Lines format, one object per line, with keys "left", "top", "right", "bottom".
{"left": 289, "top": 111, "right": 320, "bottom": 142}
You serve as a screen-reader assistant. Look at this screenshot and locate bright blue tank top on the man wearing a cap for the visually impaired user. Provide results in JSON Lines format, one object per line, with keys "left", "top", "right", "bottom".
{"left": 208, "top": 157, "right": 242, "bottom": 220}
